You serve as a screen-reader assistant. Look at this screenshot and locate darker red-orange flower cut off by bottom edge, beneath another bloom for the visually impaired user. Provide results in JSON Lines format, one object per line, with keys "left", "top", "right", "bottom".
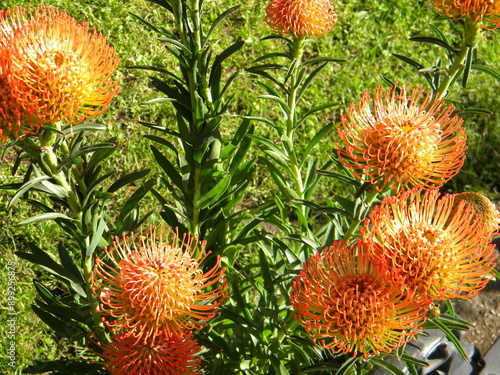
{"left": 93, "top": 332, "right": 201, "bottom": 375}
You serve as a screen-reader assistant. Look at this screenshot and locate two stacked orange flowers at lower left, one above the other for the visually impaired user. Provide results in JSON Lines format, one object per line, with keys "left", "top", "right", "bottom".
{"left": 91, "top": 227, "right": 225, "bottom": 374}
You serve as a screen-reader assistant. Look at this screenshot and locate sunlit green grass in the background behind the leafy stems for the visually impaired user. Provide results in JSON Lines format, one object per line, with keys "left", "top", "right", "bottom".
{"left": 0, "top": 0, "right": 500, "bottom": 373}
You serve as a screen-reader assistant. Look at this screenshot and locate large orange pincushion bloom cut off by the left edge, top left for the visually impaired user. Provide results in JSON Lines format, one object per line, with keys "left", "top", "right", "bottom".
{"left": 0, "top": 5, "right": 120, "bottom": 140}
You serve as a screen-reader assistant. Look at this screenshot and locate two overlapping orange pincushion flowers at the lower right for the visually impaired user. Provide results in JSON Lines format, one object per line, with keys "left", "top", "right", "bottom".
{"left": 291, "top": 189, "right": 498, "bottom": 358}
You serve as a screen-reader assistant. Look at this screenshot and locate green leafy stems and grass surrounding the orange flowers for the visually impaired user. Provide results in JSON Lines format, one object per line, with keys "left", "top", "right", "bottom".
{"left": 0, "top": 0, "right": 500, "bottom": 375}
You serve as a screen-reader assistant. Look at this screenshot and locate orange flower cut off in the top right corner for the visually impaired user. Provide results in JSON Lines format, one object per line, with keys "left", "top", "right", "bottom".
{"left": 432, "top": 0, "right": 500, "bottom": 30}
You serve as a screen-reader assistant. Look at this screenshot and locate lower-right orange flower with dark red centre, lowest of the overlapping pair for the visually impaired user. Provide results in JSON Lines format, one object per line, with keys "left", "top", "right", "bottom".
{"left": 291, "top": 241, "right": 428, "bottom": 358}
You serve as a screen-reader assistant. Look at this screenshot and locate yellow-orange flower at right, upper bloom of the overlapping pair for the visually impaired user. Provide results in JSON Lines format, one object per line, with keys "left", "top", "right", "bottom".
{"left": 365, "top": 189, "right": 496, "bottom": 301}
